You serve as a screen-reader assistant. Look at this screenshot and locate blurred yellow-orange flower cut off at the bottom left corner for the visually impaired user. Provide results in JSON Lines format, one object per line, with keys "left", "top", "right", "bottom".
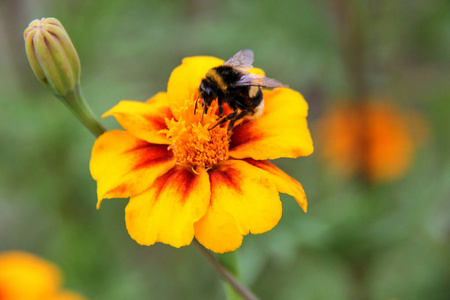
{"left": 0, "top": 251, "right": 85, "bottom": 300}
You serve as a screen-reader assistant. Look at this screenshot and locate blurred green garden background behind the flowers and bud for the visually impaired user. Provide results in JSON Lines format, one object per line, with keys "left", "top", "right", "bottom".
{"left": 0, "top": 0, "right": 450, "bottom": 300}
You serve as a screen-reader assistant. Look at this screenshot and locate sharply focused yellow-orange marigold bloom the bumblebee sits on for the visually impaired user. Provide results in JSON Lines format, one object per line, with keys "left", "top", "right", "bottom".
{"left": 90, "top": 57, "right": 313, "bottom": 253}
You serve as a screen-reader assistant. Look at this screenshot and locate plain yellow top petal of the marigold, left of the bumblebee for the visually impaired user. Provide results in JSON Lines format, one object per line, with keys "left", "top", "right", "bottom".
{"left": 167, "top": 56, "right": 223, "bottom": 119}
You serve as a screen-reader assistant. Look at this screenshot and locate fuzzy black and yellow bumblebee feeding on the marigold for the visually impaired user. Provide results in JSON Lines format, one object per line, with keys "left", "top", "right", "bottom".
{"left": 194, "top": 50, "right": 285, "bottom": 132}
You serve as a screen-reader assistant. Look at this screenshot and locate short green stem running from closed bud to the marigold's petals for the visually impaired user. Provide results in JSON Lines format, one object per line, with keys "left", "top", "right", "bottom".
{"left": 55, "top": 85, "right": 106, "bottom": 137}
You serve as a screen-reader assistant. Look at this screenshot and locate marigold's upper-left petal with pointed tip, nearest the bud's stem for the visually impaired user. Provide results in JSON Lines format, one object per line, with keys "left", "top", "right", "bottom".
{"left": 102, "top": 93, "right": 173, "bottom": 144}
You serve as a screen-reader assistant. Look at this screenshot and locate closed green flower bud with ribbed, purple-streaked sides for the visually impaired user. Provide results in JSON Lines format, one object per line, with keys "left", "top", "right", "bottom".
{"left": 24, "top": 18, "right": 80, "bottom": 96}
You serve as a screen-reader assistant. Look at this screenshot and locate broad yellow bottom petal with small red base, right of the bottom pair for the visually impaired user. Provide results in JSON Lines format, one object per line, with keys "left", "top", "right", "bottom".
{"left": 195, "top": 160, "right": 281, "bottom": 253}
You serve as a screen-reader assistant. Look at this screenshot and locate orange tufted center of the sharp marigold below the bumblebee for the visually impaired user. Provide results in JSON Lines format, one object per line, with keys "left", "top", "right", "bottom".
{"left": 161, "top": 101, "right": 229, "bottom": 172}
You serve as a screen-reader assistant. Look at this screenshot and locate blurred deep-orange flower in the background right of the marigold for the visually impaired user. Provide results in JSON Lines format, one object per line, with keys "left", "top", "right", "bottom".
{"left": 317, "top": 101, "right": 426, "bottom": 182}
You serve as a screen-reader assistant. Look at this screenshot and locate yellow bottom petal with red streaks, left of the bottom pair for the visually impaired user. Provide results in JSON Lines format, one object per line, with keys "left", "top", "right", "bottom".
{"left": 125, "top": 167, "right": 211, "bottom": 247}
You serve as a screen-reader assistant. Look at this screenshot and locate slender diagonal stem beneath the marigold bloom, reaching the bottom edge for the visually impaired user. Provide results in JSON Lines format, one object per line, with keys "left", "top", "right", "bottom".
{"left": 193, "top": 239, "right": 259, "bottom": 300}
